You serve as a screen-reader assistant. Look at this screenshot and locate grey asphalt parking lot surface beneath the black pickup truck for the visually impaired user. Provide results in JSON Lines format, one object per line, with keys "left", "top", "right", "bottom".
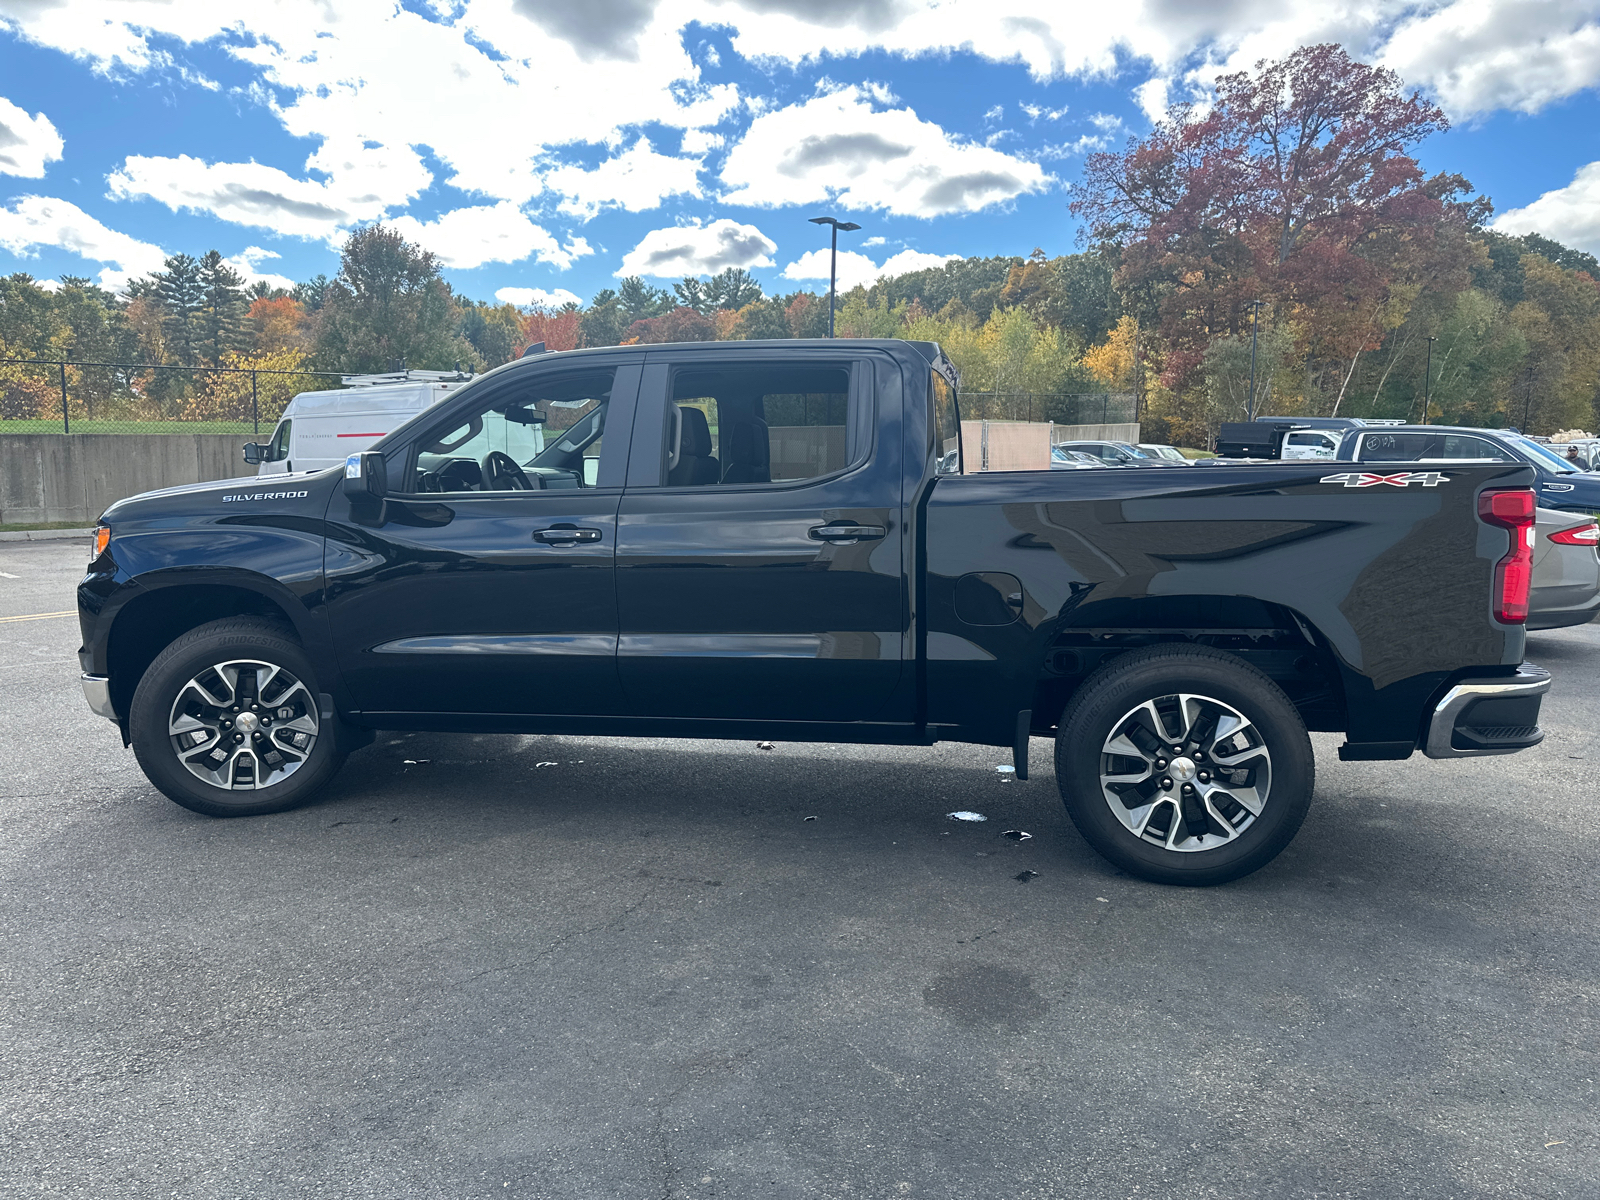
{"left": 0, "top": 542, "right": 1600, "bottom": 1200}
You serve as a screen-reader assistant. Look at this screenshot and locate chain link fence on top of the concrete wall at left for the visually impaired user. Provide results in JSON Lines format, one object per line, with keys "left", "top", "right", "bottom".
{"left": 0, "top": 358, "right": 341, "bottom": 435}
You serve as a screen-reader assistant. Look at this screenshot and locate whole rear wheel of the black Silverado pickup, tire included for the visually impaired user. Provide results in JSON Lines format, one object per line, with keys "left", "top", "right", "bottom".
{"left": 1056, "top": 645, "right": 1315, "bottom": 886}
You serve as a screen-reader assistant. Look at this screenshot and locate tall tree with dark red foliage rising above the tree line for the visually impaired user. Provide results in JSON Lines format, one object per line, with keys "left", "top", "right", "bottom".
{"left": 1072, "top": 45, "right": 1486, "bottom": 409}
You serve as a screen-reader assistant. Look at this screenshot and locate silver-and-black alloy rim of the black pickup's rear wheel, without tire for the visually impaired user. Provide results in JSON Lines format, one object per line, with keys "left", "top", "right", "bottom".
{"left": 1101, "top": 693, "right": 1272, "bottom": 853}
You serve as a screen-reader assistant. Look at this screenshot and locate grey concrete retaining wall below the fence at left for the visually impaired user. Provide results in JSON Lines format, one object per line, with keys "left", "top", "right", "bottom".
{"left": 0, "top": 434, "right": 256, "bottom": 525}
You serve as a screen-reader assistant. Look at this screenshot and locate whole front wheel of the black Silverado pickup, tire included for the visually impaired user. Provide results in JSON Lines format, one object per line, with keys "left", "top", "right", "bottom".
{"left": 128, "top": 618, "right": 349, "bottom": 816}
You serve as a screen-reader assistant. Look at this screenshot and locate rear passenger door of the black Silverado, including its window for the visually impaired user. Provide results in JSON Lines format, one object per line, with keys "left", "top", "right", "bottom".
{"left": 618, "top": 347, "right": 912, "bottom": 722}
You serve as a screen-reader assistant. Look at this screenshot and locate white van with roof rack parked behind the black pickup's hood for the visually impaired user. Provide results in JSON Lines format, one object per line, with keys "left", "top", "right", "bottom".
{"left": 245, "top": 371, "right": 472, "bottom": 475}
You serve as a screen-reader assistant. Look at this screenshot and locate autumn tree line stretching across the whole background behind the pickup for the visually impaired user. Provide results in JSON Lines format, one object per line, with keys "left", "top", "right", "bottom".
{"left": 9, "top": 45, "right": 1600, "bottom": 446}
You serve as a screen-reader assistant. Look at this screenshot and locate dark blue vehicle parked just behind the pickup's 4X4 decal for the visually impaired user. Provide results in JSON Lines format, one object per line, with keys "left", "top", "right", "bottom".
{"left": 1339, "top": 426, "right": 1600, "bottom": 514}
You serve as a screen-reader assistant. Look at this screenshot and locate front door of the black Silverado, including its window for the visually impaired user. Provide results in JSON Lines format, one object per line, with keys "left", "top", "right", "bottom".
{"left": 326, "top": 363, "right": 640, "bottom": 715}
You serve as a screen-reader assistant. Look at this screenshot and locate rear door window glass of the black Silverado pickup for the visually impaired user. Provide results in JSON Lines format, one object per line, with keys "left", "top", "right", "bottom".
{"left": 664, "top": 362, "right": 851, "bottom": 488}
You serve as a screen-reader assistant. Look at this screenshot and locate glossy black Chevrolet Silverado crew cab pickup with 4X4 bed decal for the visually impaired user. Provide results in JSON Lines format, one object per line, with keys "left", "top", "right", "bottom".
{"left": 78, "top": 341, "right": 1549, "bottom": 883}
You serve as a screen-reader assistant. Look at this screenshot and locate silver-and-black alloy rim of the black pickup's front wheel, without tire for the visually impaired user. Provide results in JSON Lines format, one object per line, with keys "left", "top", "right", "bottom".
{"left": 166, "top": 659, "right": 318, "bottom": 792}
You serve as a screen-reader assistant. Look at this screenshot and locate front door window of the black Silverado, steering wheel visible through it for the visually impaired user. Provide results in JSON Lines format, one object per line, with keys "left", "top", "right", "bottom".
{"left": 413, "top": 371, "right": 616, "bottom": 493}
